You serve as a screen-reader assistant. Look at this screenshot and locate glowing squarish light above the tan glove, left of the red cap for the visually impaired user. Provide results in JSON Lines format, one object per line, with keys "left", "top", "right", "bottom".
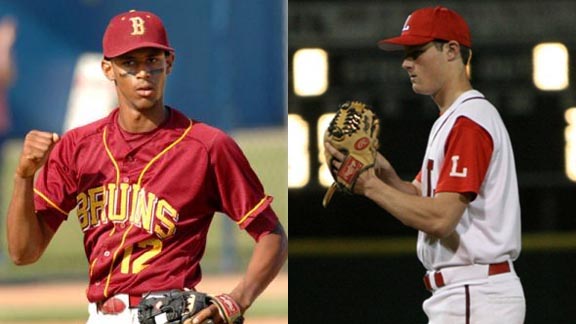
{"left": 292, "top": 48, "right": 328, "bottom": 97}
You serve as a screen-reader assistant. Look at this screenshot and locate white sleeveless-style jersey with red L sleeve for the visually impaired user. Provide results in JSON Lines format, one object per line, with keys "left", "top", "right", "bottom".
{"left": 417, "top": 90, "right": 521, "bottom": 270}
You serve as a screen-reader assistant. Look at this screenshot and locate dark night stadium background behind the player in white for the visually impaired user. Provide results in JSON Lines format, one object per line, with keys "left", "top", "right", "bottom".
{"left": 288, "top": 0, "right": 576, "bottom": 323}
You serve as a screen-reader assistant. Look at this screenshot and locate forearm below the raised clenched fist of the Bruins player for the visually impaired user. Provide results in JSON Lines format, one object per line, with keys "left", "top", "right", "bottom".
{"left": 7, "top": 176, "right": 51, "bottom": 265}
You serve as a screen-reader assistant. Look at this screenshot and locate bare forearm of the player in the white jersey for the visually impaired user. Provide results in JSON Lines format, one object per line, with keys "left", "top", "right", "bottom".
{"left": 364, "top": 178, "right": 466, "bottom": 238}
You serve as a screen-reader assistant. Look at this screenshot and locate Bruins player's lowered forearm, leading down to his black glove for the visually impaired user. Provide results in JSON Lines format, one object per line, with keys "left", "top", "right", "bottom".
{"left": 230, "top": 224, "right": 288, "bottom": 310}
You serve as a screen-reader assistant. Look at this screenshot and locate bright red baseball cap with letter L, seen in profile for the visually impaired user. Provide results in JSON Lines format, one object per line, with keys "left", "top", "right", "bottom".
{"left": 378, "top": 6, "right": 472, "bottom": 51}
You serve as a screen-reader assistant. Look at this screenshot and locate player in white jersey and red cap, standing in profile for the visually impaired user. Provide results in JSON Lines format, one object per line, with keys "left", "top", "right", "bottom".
{"left": 326, "top": 7, "right": 525, "bottom": 324}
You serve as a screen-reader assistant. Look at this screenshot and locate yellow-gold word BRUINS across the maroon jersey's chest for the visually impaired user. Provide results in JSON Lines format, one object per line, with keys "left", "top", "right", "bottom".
{"left": 76, "top": 183, "right": 178, "bottom": 240}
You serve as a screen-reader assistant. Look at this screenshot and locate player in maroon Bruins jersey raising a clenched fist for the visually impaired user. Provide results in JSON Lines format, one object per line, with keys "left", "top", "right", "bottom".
{"left": 7, "top": 11, "right": 287, "bottom": 324}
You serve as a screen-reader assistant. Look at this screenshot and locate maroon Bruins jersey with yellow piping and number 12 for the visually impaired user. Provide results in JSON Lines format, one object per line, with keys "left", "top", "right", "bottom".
{"left": 34, "top": 109, "right": 277, "bottom": 302}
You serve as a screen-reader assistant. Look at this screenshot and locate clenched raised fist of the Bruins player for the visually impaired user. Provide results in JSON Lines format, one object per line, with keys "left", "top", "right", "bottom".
{"left": 16, "top": 130, "right": 60, "bottom": 178}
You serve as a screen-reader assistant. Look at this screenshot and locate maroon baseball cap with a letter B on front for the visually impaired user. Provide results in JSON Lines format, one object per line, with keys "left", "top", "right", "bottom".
{"left": 102, "top": 10, "right": 174, "bottom": 58}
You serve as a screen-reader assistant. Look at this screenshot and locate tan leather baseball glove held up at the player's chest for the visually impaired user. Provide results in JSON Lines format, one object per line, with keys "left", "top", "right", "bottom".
{"left": 322, "top": 101, "right": 380, "bottom": 207}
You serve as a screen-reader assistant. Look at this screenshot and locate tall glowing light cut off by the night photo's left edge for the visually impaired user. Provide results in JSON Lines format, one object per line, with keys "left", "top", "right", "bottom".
{"left": 288, "top": 114, "right": 310, "bottom": 188}
